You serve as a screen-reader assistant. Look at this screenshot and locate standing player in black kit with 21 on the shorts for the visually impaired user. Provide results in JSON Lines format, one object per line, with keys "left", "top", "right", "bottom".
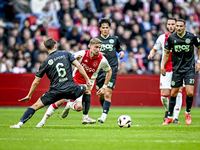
{"left": 161, "top": 19, "right": 200, "bottom": 125}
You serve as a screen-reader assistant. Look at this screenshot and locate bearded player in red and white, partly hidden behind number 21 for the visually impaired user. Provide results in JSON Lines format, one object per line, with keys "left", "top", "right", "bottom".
{"left": 148, "top": 18, "right": 183, "bottom": 123}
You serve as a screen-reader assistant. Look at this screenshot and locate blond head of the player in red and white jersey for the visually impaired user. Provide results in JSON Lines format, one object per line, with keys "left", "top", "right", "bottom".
{"left": 90, "top": 38, "right": 102, "bottom": 57}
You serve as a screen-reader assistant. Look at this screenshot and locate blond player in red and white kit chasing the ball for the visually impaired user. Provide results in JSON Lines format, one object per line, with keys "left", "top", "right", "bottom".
{"left": 36, "top": 38, "right": 112, "bottom": 127}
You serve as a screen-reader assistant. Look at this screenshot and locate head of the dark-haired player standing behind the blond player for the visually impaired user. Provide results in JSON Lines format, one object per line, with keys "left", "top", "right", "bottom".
{"left": 99, "top": 18, "right": 111, "bottom": 37}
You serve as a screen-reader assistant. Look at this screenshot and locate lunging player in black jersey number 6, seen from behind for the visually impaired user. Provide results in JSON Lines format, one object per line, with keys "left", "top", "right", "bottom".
{"left": 10, "top": 38, "right": 91, "bottom": 128}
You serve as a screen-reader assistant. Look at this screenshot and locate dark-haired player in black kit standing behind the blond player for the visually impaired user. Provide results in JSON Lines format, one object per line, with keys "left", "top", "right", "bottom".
{"left": 96, "top": 18, "right": 124, "bottom": 123}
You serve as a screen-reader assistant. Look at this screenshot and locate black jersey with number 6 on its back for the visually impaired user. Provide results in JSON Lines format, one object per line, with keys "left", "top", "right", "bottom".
{"left": 35, "top": 51, "right": 76, "bottom": 92}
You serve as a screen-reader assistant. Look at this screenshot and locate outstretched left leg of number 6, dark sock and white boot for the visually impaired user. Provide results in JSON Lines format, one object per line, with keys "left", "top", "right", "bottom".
{"left": 10, "top": 98, "right": 44, "bottom": 128}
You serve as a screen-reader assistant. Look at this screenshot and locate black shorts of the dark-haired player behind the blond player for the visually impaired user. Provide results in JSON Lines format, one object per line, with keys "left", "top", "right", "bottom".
{"left": 96, "top": 66, "right": 118, "bottom": 91}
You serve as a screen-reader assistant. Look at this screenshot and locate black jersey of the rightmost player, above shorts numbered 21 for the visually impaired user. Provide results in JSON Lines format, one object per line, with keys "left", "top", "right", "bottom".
{"left": 165, "top": 31, "right": 200, "bottom": 73}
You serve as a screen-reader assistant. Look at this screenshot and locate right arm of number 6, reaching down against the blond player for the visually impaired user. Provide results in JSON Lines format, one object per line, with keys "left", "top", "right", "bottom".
{"left": 73, "top": 60, "right": 92, "bottom": 90}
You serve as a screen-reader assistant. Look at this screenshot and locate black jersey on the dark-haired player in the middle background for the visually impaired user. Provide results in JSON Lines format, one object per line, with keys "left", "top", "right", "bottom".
{"left": 96, "top": 35, "right": 123, "bottom": 67}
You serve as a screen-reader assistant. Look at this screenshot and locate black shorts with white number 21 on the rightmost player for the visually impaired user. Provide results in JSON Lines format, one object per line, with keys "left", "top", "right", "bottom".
{"left": 171, "top": 68, "right": 195, "bottom": 88}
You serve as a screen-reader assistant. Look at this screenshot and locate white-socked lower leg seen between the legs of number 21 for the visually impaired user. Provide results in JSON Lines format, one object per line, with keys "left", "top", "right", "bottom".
{"left": 173, "top": 86, "right": 183, "bottom": 123}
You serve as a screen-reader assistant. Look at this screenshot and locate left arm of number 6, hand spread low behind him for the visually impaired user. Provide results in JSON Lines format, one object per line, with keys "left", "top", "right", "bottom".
{"left": 18, "top": 77, "right": 41, "bottom": 102}
